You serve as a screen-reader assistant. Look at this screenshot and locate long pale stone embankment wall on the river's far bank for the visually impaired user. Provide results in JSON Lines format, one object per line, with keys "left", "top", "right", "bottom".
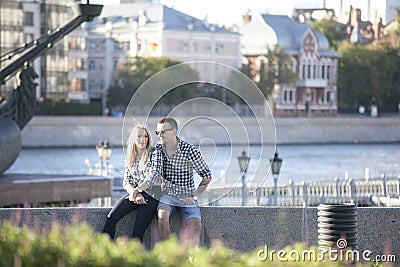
{"left": 22, "top": 115, "right": 400, "bottom": 147}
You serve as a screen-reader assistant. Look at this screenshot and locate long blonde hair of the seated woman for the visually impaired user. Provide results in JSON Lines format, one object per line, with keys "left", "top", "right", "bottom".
{"left": 126, "top": 125, "right": 152, "bottom": 173}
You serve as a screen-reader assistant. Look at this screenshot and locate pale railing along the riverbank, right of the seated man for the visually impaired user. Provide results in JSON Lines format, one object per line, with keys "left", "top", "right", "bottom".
{"left": 202, "top": 177, "right": 400, "bottom": 207}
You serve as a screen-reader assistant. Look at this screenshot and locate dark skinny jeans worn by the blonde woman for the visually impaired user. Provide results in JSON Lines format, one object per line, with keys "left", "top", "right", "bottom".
{"left": 103, "top": 186, "right": 161, "bottom": 243}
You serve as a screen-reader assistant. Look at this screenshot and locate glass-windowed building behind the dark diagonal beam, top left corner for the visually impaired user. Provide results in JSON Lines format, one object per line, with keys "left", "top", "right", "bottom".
{"left": 0, "top": 0, "right": 74, "bottom": 99}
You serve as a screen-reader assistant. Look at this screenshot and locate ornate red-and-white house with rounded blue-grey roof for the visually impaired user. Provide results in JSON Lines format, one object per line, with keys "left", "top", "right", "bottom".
{"left": 241, "top": 14, "right": 340, "bottom": 116}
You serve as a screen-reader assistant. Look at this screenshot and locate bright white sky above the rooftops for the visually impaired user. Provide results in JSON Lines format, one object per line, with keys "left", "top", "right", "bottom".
{"left": 90, "top": 0, "right": 367, "bottom": 26}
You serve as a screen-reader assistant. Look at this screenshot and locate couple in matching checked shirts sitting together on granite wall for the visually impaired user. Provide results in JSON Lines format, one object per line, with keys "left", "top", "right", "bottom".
{"left": 103, "top": 118, "right": 211, "bottom": 246}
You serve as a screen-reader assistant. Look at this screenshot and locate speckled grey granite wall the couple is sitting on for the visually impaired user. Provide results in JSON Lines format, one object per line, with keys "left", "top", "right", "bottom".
{"left": 0, "top": 207, "right": 400, "bottom": 261}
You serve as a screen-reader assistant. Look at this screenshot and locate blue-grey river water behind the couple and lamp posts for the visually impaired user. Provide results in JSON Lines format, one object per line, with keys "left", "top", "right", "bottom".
{"left": 6, "top": 144, "right": 400, "bottom": 185}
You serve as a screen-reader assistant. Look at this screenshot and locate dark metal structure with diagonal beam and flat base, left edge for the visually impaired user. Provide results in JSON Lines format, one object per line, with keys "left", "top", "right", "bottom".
{"left": 0, "top": 1, "right": 112, "bottom": 207}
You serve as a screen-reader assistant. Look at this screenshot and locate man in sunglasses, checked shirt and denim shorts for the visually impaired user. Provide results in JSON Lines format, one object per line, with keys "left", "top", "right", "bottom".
{"left": 156, "top": 118, "right": 211, "bottom": 246}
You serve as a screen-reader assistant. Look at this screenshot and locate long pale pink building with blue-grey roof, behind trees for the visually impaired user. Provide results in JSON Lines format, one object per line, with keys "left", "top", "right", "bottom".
{"left": 70, "top": 3, "right": 241, "bottom": 104}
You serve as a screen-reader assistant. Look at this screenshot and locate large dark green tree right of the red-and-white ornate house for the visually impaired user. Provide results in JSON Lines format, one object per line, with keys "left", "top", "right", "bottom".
{"left": 338, "top": 43, "right": 400, "bottom": 112}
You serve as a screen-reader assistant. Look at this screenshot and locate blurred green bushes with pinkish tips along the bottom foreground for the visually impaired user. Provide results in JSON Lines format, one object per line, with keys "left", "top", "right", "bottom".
{"left": 0, "top": 221, "right": 376, "bottom": 267}
